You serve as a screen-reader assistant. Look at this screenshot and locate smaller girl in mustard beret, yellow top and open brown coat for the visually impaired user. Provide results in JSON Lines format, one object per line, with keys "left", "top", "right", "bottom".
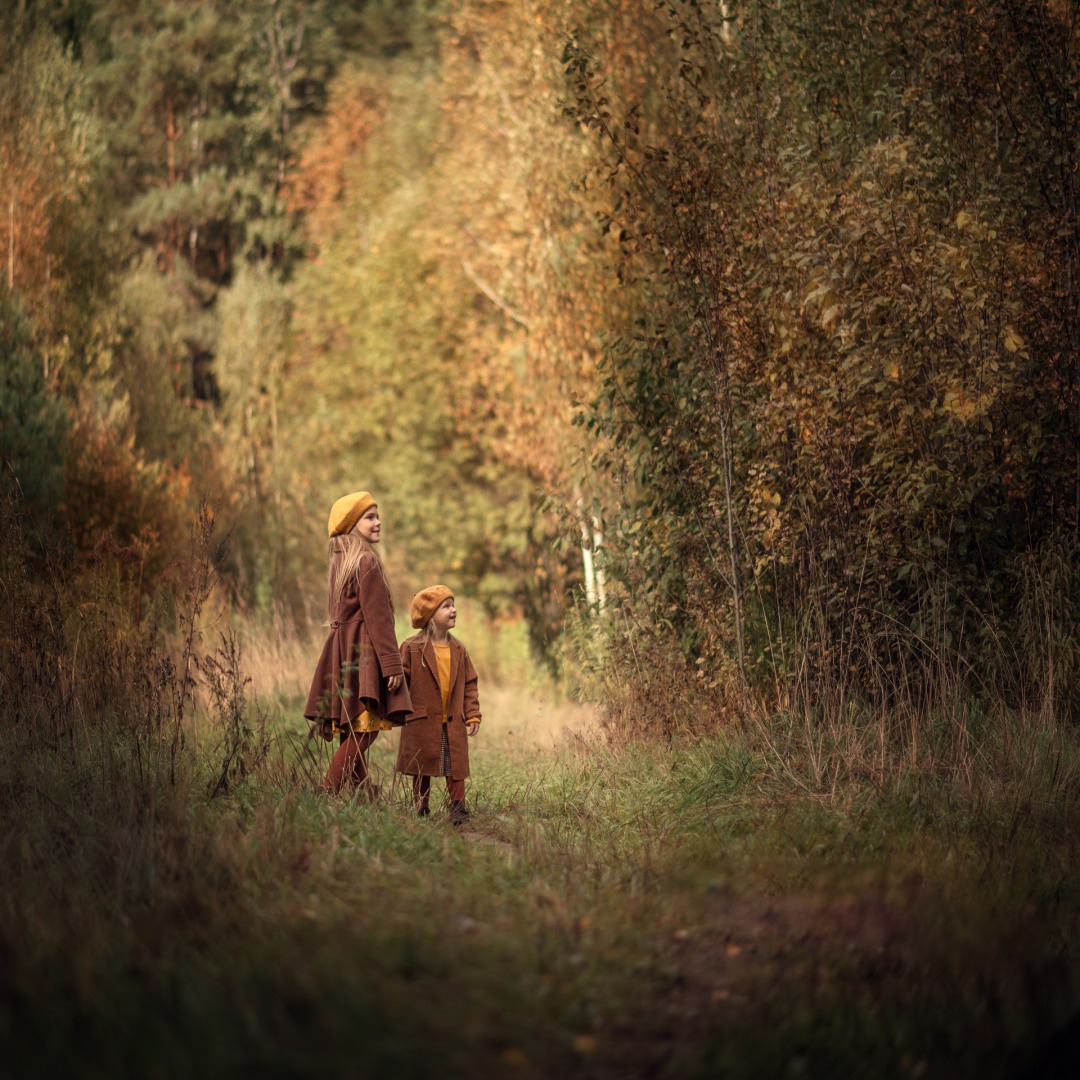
{"left": 397, "top": 585, "right": 480, "bottom": 825}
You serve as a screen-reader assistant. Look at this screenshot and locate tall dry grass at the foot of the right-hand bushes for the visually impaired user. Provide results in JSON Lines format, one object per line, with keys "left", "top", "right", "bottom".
{"left": 570, "top": 536, "right": 1080, "bottom": 862}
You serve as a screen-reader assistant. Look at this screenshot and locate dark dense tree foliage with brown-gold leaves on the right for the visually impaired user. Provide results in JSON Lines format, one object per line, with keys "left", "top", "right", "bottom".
{"left": 568, "top": 0, "right": 1077, "bottom": 685}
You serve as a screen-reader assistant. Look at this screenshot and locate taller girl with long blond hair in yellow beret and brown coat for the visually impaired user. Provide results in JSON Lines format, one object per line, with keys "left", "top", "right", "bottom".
{"left": 303, "top": 491, "right": 413, "bottom": 799}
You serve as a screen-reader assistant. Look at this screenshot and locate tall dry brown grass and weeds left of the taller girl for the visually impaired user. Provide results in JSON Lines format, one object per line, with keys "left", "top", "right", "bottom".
{"left": 0, "top": 490, "right": 278, "bottom": 868}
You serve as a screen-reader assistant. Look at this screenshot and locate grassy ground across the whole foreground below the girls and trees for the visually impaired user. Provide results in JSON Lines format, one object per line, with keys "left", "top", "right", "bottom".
{"left": 0, "top": 678, "right": 1080, "bottom": 1077}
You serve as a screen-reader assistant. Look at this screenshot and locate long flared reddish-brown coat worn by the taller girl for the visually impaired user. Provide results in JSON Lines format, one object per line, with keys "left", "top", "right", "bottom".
{"left": 303, "top": 554, "right": 413, "bottom": 726}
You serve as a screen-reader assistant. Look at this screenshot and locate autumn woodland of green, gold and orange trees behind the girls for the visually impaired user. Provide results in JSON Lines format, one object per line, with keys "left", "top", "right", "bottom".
{"left": 0, "top": 0, "right": 1080, "bottom": 692}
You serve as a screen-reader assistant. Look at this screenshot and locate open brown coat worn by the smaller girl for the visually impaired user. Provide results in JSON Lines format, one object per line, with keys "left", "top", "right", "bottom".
{"left": 397, "top": 634, "right": 480, "bottom": 780}
